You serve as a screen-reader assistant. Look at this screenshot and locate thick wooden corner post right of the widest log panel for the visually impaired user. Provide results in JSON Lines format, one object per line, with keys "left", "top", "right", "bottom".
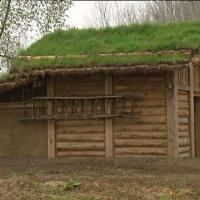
{"left": 167, "top": 71, "right": 179, "bottom": 158}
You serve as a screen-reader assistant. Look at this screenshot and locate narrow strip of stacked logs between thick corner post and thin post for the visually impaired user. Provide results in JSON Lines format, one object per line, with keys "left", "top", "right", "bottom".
{"left": 178, "top": 90, "right": 191, "bottom": 158}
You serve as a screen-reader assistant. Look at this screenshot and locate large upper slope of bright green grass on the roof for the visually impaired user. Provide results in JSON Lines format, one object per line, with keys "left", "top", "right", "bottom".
{"left": 20, "top": 21, "right": 200, "bottom": 56}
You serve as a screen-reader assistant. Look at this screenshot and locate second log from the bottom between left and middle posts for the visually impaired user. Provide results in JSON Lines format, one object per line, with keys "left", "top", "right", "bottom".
{"left": 56, "top": 142, "right": 105, "bottom": 151}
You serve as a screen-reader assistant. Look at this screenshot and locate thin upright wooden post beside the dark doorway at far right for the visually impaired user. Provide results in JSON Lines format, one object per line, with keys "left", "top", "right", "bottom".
{"left": 189, "top": 63, "right": 195, "bottom": 158}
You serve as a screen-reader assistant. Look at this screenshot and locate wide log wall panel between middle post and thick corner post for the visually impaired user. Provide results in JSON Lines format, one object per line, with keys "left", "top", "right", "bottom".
{"left": 114, "top": 75, "right": 167, "bottom": 156}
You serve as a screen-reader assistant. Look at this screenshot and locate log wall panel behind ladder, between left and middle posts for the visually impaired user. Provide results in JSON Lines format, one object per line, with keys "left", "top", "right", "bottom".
{"left": 55, "top": 76, "right": 105, "bottom": 156}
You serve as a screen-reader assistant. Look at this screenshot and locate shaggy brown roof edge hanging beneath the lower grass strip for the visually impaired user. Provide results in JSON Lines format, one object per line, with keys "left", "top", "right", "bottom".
{"left": 0, "top": 63, "right": 189, "bottom": 93}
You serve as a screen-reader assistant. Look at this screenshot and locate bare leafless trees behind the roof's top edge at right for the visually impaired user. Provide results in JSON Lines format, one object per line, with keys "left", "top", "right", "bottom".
{"left": 87, "top": 0, "right": 200, "bottom": 27}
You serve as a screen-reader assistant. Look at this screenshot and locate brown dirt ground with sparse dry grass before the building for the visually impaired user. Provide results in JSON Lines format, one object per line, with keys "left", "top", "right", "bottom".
{"left": 0, "top": 158, "right": 200, "bottom": 200}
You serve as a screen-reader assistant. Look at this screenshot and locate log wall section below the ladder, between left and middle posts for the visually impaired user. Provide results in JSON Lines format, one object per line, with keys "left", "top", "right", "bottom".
{"left": 56, "top": 120, "right": 105, "bottom": 156}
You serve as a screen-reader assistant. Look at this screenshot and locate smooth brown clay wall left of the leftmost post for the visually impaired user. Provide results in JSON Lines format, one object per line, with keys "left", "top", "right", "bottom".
{"left": 0, "top": 103, "right": 47, "bottom": 157}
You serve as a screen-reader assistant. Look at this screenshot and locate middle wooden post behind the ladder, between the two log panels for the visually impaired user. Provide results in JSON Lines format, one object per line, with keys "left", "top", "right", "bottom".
{"left": 105, "top": 75, "right": 114, "bottom": 158}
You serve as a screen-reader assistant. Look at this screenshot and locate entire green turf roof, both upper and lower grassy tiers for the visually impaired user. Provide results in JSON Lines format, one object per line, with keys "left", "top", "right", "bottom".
{"left": 11, "top": 21, "right": 200, "bottom": 72}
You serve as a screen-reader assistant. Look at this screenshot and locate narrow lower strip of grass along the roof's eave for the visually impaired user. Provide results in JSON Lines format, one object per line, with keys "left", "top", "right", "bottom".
{"left": 10, "top": 53, "right": 190, "bottom": 73}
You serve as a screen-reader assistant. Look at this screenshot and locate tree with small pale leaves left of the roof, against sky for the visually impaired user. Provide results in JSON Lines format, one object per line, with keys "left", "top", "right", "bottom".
{"left": 0, "top": 0, "right": 71, "bottom": 70}
